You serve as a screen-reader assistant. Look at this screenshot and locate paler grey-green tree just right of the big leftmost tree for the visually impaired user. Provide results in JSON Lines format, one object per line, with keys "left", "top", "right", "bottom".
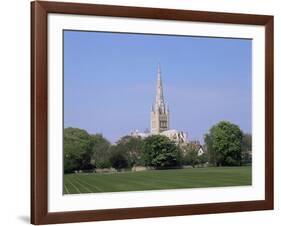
{"left": 91, "top": 134, "right": 111, "bottom": 168}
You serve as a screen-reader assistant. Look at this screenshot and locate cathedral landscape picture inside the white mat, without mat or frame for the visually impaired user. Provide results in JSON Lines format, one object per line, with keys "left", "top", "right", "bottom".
{"left": 63, "top": 30, "right": 252, "bottom": 195}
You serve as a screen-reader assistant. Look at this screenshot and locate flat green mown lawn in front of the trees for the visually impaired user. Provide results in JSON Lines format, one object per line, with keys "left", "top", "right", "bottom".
{"left": 64, "top": 166, "right": 252, "bottom": 194}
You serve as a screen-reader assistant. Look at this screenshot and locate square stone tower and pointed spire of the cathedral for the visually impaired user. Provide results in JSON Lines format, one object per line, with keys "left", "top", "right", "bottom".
{"left": 150, "top": 64, "right": 169, "bottom": 134}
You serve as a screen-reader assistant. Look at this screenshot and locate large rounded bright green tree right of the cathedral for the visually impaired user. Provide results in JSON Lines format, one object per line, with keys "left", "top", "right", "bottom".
{"left": 205, "top": 121, "right": 242, "bottom": 166}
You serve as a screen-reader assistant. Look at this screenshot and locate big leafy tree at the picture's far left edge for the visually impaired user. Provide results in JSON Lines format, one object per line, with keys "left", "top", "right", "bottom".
{"left": 63, "top": 127, "right": 92, "bottom": 173}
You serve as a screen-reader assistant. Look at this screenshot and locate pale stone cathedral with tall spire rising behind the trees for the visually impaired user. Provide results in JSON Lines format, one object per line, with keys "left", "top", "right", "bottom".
{"left": 131, "top": 65, "right": 188, "bottom": 144}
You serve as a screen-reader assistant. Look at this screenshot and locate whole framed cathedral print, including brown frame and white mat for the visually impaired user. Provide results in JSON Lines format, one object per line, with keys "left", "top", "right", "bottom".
{"left": 31, "top": 1, "right": 273, "bottom": 224}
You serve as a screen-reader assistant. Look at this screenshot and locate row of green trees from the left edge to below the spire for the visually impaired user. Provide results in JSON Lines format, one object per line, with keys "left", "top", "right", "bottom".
{"left": 64, "top": 128, "right": 182, "bottom": 173}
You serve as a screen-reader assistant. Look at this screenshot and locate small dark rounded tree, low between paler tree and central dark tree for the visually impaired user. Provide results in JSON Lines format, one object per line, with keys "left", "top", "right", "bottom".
{"left": 109, "top": 146, "right": 129, "bottom": 171}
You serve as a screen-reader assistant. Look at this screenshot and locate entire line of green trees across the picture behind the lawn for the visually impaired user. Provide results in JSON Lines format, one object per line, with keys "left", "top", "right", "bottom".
{"left": 64, "top": 121, "right": 251, "bottom": 173}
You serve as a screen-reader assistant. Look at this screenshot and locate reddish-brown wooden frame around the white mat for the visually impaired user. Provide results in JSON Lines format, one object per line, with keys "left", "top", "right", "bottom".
{"left": 31, "top": 1, "right": 274, "bottom": 224}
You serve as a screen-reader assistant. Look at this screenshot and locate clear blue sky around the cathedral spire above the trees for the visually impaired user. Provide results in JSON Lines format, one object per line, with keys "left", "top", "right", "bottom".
{"left": 64, "top": 31, "right": 252, "bottom": 142}
